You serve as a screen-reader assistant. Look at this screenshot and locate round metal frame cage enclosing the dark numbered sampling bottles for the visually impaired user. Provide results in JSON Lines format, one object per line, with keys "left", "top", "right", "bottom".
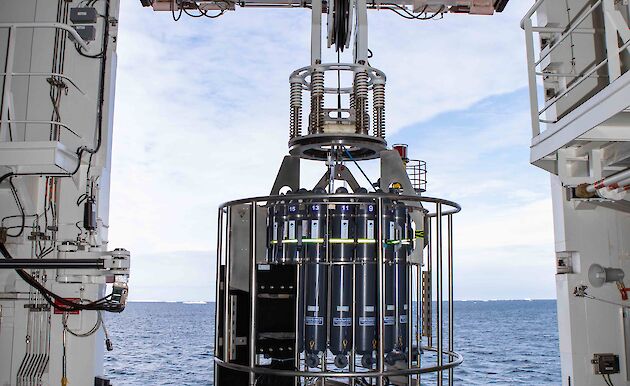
{"left": 214, "top": 193, "right": 463, "bottom": 386}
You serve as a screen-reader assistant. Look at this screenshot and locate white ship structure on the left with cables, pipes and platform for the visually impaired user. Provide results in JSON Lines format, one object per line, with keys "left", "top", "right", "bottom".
{"left": 0, "top": 0, "right": 129, "bottom": 385}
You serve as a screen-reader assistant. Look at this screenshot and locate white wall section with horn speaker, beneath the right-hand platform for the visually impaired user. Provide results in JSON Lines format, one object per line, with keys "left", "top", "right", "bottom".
{"left": 552, "top": 176, "right": 630, "bottom": 386}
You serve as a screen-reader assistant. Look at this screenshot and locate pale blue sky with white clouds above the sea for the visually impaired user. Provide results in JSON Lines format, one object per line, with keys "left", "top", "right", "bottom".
{"left": 109, "top": 1, "right": 555, "bottom": 301}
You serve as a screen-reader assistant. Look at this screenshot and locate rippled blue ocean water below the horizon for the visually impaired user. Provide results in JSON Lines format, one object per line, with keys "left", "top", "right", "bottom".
{"left": 105, "top": 300, "right": 561, "bottom": 386}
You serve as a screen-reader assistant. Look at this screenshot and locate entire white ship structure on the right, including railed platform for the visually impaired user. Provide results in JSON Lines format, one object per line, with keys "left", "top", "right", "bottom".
{"left": 522, "top": 0, "right": 630, "bottom": 386}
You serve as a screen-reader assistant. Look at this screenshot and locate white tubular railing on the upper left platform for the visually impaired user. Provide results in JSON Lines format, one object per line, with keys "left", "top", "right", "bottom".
{"left": 0, "top": 23, "right": 91, "bottom": 140}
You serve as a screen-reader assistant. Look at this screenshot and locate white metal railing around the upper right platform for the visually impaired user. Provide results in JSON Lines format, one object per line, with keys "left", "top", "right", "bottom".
{"left": 521, "top": 0, "right": 630, "bottom": 137}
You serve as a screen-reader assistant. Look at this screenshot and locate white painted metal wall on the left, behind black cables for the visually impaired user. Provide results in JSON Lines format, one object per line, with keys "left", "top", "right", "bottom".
{"left": 0, "top": 0, "right": 124, "bottom": 385}
